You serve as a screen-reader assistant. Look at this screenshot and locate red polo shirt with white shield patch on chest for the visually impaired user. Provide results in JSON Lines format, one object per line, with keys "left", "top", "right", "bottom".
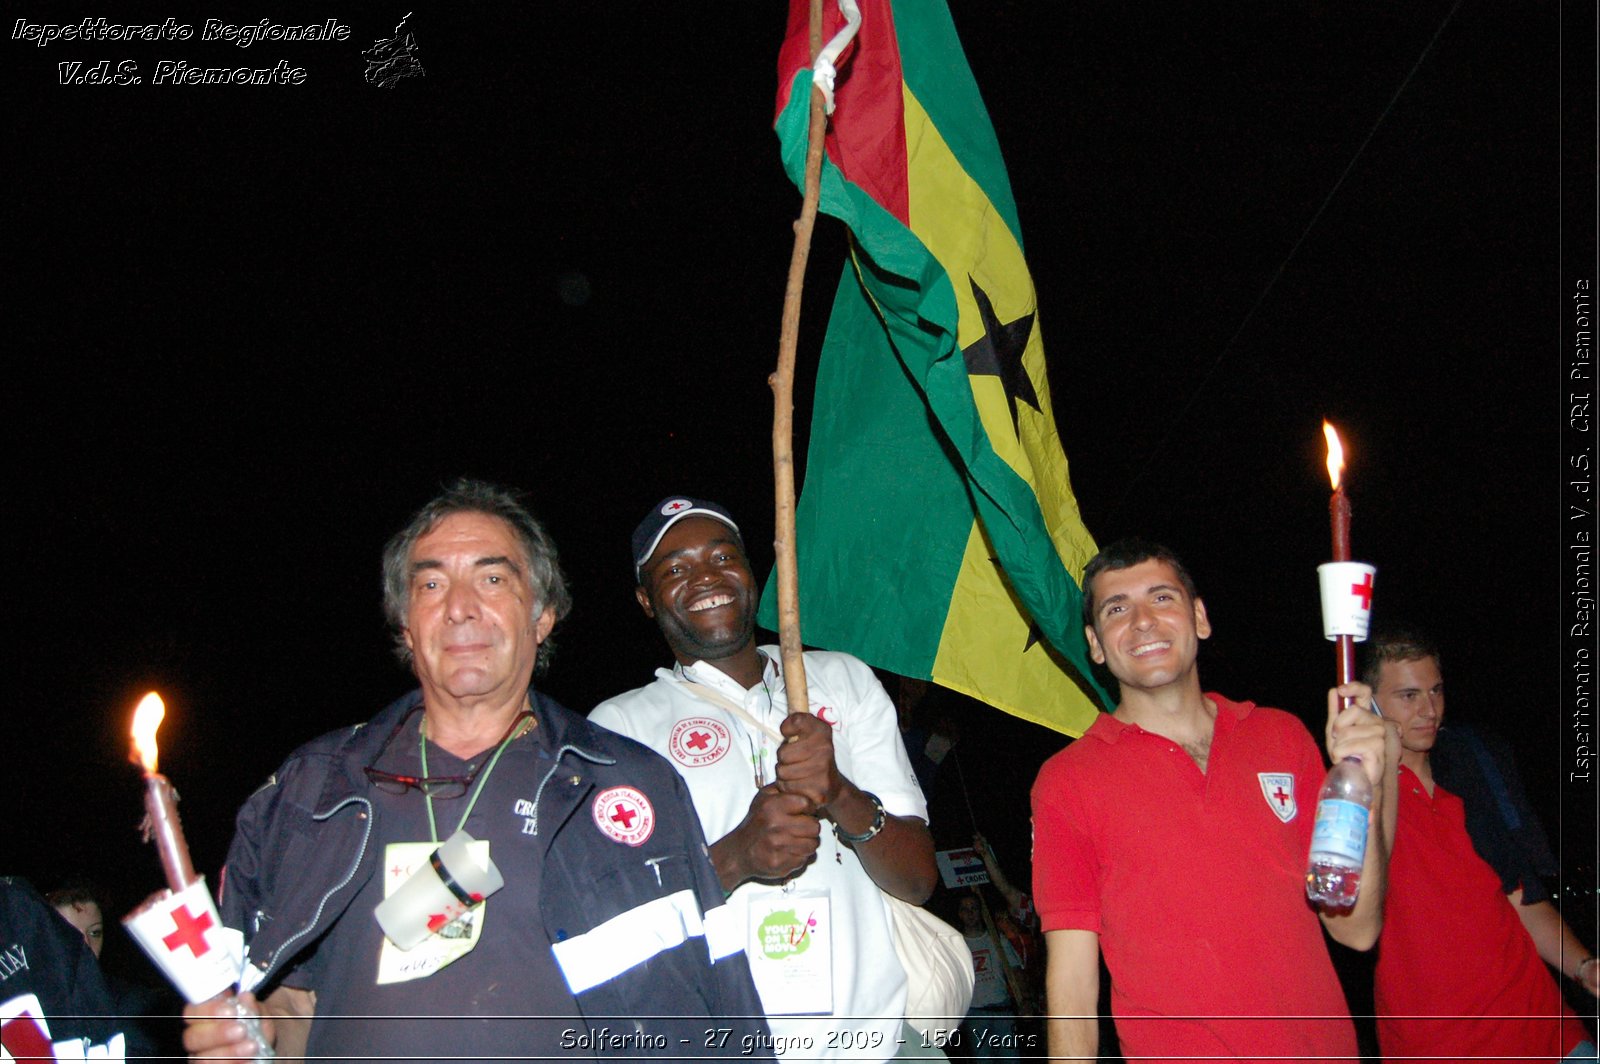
{"left": 1034, "top": 694, "right": 1357, "bottom": 1062}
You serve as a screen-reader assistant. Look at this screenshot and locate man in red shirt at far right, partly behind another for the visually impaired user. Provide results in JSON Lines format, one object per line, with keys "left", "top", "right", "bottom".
{"left": 1366, "top": 632, "right": 1600, "bottom": 1061}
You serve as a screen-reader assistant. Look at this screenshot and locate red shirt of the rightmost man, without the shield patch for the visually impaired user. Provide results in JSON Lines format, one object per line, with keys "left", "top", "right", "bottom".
{"left": 1373, "top": 765, "right": 1589, "bottom": 1061}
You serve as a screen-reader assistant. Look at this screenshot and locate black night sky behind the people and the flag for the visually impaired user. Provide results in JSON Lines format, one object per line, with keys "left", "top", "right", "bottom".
{"left": 0, "top": 0, "right": 1595, "bottom": 998}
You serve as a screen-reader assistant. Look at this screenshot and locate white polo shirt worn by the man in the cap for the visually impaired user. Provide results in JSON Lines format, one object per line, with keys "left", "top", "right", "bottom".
{"left": 589, "top": 646, "right": 928, "bottom": 1061}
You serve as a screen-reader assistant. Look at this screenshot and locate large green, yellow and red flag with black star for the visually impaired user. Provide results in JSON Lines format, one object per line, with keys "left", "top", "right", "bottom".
{"left": 762, "top": 0, "right": 1110, "bottom": 736}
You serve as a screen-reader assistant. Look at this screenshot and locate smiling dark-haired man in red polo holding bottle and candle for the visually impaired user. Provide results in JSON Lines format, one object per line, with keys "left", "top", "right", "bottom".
{"left": 1034, "top": 539, "right": 1397, "bottom": 1061}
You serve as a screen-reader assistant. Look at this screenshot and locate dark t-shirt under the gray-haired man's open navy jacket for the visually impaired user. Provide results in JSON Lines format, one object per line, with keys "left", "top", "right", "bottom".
{"left": 297, "top": 714, "right": 589, "bottom": 1061}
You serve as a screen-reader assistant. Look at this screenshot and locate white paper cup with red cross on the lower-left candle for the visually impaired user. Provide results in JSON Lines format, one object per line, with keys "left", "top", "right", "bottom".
{"left": 122, "top": 878, "right": 245, "bottom": 1002}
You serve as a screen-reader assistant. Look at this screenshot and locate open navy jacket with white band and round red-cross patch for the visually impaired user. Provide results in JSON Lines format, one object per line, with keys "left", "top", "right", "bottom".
{"left": 219, "top": 691, "right": 771, "bottom": 1059}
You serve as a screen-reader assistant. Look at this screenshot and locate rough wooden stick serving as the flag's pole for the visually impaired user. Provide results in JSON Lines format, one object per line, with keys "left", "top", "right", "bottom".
{"left": 766, "top": 0, "right": 827, "bottom": 714}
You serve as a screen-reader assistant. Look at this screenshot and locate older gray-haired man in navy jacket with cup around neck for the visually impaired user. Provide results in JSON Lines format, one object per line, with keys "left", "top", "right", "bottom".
{"left": 186, "top": 480, "right": 766, "bottom": 1061}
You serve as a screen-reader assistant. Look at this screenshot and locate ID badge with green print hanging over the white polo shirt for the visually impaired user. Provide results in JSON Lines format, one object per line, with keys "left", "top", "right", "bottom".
{"left": 746, "top": 890, "right": 834, "bottom": 1016}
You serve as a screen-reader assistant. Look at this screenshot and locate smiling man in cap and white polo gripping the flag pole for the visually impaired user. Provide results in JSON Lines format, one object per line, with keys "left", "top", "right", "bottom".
{"left": 590, "top": 496, "right": 941, "bottom": 1061}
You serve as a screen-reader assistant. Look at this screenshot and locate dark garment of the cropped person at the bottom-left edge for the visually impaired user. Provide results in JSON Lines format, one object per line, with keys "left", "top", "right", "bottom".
{"left": 0, "top": 877, "right": 122, "bottom": 1059}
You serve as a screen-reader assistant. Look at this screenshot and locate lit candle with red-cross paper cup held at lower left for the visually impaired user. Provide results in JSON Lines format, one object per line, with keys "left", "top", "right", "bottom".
{"left": 122, "top": 691, "right": 274, "bottom": 1061}
